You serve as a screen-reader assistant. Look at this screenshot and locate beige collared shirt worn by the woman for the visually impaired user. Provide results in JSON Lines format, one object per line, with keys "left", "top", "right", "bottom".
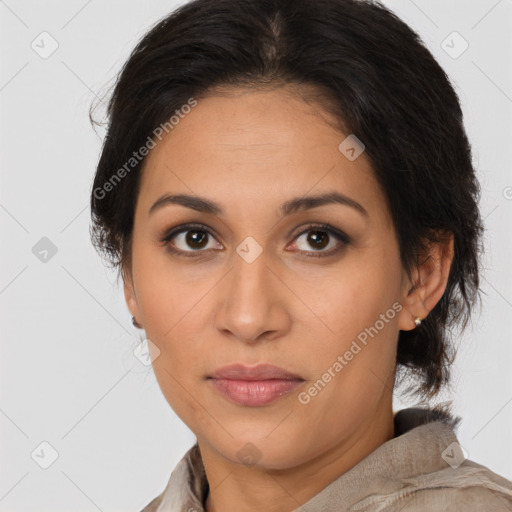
{"left": 142, "top": 408, "right": 512, "bottom": 512}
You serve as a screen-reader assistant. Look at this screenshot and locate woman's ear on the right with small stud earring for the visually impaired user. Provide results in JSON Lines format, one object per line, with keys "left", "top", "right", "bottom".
{"left": 398, "top": 233, "right": 454, "bottom": 331}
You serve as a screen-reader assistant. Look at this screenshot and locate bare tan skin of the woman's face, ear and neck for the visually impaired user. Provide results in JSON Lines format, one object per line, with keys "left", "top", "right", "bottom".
{"left": 124, "top": 88, "right": 453, "bottom": 512}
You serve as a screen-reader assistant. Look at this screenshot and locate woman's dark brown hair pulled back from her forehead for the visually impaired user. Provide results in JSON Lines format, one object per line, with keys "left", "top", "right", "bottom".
{"left": 91, "top": 0, "right": 483, "bottom": 398}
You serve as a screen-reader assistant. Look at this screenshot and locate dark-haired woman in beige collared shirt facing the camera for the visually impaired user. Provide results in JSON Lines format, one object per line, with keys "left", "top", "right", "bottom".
{"left": 91, "top": 0, "right": 512, "bottom": 512}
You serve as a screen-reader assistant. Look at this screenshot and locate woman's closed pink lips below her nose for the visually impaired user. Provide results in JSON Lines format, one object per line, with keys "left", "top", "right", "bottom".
{"left": 208, "top": 364, "right": 304, "bottom": 407}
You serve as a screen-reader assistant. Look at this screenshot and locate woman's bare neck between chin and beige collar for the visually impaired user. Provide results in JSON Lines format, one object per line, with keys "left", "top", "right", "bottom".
{"left": 198, "top": 404, "right": 395, "bottom": 512}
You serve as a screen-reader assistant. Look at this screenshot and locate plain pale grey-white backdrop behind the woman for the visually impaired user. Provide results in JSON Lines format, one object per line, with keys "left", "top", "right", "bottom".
{"left": 0, "top": 0, "right": 512, "bottom": 512}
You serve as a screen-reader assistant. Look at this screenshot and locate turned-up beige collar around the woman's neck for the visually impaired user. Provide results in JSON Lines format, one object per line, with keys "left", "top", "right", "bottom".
{"left": 155, "top": 406, "right": 461, "bottom": 512}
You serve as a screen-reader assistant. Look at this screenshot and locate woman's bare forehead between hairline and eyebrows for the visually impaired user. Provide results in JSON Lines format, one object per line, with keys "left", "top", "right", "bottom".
{"left": 139, "top": 89, "right": 383, "bottom": 222}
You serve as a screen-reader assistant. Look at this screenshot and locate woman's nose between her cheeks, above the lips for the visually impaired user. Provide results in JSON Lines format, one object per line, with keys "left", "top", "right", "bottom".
{"left": 215, "top": 246, "right": 292, "bottom": 344}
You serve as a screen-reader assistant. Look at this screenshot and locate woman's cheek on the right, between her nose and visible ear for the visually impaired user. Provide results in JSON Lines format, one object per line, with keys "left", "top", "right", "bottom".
{"left": 296, "top": 246, "right": 401, "bottom": 394}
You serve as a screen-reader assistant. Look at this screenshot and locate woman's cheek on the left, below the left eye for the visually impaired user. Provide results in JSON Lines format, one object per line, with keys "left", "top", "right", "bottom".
{"left": 134, "top": 246, "right": 216, "bottom": 408}
